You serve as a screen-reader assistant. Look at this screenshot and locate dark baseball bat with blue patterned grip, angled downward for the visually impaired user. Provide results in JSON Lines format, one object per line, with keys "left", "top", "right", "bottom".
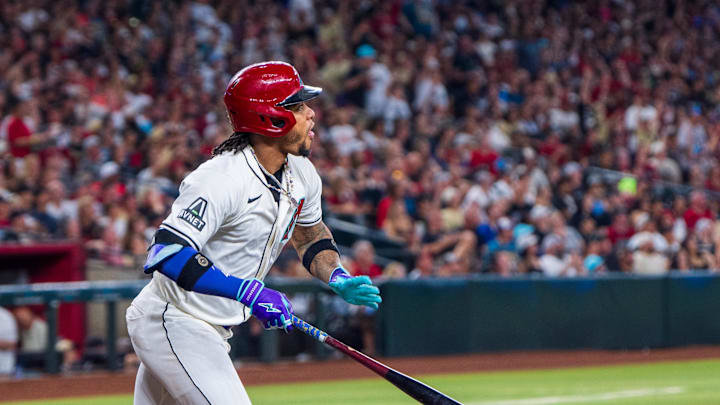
{"left": 293, "top": 315, "right": 462, "bottom": 405}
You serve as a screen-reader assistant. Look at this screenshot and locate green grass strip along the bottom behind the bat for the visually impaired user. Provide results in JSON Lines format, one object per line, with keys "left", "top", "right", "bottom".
{"left": 4, "top": 360, "right": 720, "bottom": 405}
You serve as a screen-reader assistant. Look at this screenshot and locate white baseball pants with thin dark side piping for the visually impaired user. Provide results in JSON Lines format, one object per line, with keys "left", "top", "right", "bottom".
{"left": 125, "top": 288, "right": 250, "bottom": 405}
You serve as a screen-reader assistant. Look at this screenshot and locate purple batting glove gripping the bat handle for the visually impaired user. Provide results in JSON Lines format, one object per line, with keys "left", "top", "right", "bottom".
{"left": 237, "top": 278, "right": 293, "bottom": 332}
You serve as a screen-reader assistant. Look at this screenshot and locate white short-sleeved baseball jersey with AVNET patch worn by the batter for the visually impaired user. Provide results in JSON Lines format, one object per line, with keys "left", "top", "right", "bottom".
{"left": 148, "top": 147, "right": 322, "bottom": 326}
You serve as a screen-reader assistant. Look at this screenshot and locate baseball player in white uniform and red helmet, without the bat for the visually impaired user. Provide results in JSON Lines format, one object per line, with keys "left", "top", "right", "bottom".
{"left": 126, "top": 62, "right": 381, "bottom": 405}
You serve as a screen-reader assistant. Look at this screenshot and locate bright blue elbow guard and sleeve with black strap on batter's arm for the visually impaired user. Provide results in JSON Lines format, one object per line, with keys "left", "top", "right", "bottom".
{"left": 143, "top": 243, "right": 248, "bottom": 300}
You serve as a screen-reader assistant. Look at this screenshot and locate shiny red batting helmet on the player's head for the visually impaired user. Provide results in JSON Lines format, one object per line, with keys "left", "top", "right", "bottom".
{"left": 224, "top": 62, "right": 322, "bottom": 137}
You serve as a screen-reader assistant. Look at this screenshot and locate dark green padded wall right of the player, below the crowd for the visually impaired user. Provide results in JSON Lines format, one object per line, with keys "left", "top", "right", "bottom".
{"left": 377, "top": 273, "right": 720, "bottom": 356}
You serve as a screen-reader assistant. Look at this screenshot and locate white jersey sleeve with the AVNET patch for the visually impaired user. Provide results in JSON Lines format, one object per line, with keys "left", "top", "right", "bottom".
{"left": 160, "top": 170, "right": 236, "bottom": 251}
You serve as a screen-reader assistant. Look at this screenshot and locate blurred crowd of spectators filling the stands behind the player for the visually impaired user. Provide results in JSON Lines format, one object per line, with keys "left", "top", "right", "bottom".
{"left": 0, "top": 0, "right": 720, "bottom": 278}
